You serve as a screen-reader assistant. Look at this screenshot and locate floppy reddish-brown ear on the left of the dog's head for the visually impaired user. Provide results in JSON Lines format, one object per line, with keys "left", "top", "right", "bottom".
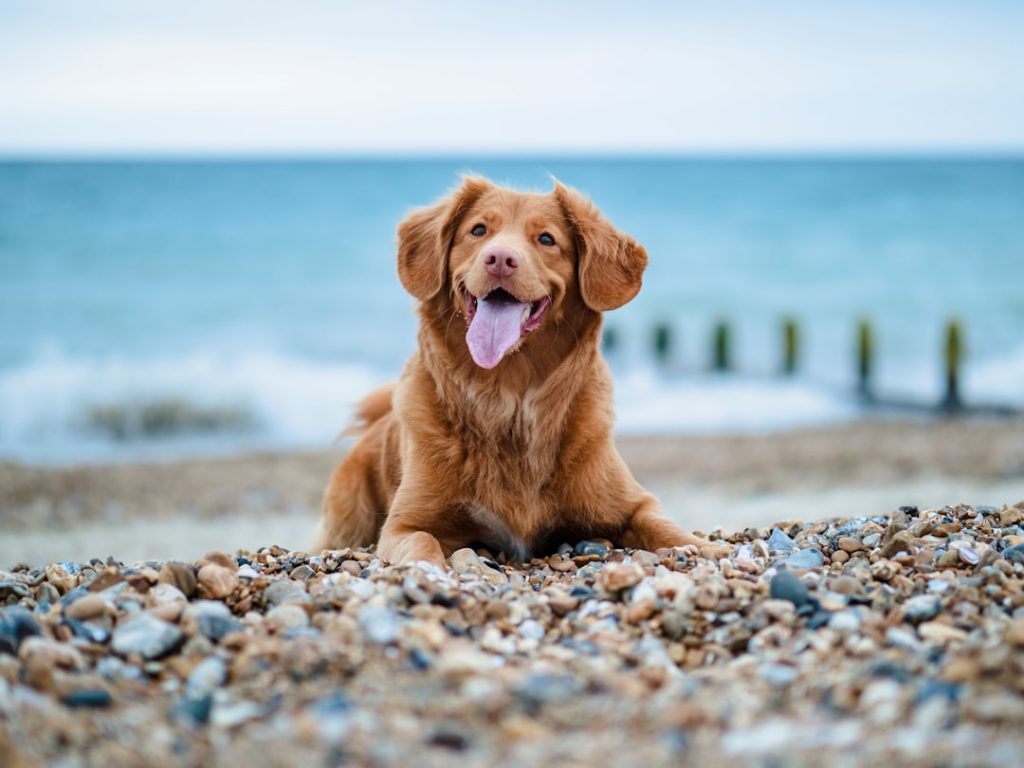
{"left": 398, "top": 176, "right": 493, "bottom": 301}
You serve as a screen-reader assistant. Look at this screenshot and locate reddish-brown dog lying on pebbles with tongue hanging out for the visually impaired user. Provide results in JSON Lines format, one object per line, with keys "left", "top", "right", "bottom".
{"left": 317, "top": 178, "right": 730, "bottom": 564}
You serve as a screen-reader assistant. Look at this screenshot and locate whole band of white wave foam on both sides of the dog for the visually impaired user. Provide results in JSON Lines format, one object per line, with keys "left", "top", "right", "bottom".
{"left": 0, "top": 348, "right": 1024, "bottom": 463}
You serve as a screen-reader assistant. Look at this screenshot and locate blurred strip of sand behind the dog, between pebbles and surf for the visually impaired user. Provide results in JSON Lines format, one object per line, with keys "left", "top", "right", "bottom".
{"left": 0, "top": 420, "right": 1024, "bottom": 567}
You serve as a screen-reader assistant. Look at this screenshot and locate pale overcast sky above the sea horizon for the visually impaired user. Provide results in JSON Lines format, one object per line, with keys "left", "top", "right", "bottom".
{"left": 0, "top": 0, "right": 1024, "bottom": 155}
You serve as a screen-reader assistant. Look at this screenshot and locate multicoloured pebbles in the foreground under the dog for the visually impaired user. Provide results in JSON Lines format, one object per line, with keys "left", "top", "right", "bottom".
{"left": 0, "top": 503, "right": 1024, "bottom": 768}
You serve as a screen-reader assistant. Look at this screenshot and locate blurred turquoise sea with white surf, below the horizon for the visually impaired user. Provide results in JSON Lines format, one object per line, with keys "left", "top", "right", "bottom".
{"left": 0, "top": 158, "right": 1024, "bottom": 464}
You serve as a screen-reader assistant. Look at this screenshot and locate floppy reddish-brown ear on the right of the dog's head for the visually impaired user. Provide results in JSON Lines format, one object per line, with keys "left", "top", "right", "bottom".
{"left": 555, "top": 181, "right": 647, "bottom": 312}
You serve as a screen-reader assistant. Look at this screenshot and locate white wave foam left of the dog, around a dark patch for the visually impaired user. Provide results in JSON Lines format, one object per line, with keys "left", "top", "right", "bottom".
{"left": 0, "top": 353, "right": 386, "bottom": 462}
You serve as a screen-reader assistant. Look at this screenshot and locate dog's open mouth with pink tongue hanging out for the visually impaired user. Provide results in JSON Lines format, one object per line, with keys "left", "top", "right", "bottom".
{"left": 463, "top": 288, "right": 551, "bottom": 369}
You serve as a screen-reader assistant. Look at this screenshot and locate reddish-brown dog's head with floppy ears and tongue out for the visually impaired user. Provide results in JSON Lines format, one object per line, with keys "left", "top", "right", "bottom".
{"left": 398, "top": 177, "right": 647, "bottom": 369}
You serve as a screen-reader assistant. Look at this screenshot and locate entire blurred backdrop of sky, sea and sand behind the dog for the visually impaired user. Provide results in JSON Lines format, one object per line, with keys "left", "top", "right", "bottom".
{"left": 0, "top": 0, "right": 1024, "bottom": 565}
